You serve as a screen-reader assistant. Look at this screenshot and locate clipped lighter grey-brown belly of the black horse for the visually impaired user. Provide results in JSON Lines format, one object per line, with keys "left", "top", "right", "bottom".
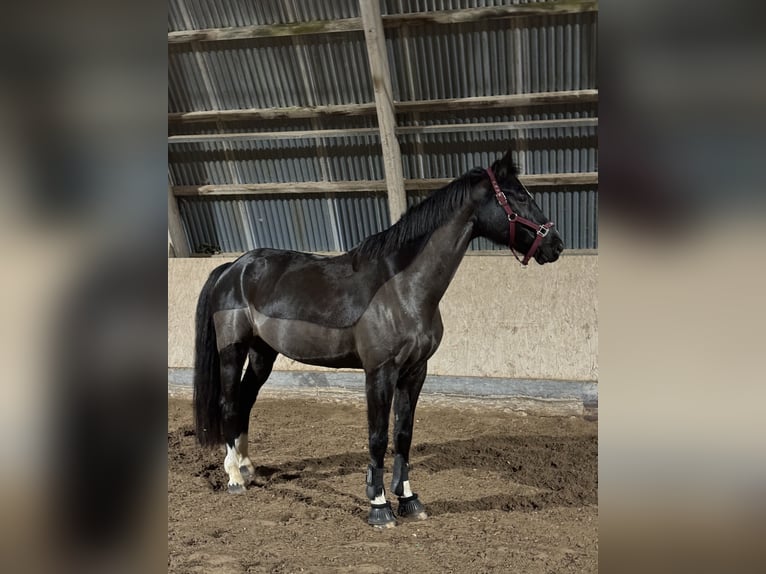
{"left": 253, "top": 311, "right": 361, "bottom": 368}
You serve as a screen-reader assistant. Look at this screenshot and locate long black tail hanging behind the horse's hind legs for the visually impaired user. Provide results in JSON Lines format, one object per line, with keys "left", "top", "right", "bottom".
{"left": 194, "top": 263, "right": 231, "bottom": 446}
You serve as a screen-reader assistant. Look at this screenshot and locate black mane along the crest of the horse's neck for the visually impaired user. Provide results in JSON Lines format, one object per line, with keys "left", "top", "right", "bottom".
{"left": 351, "top": 168, "right": 483, "bottom": 260}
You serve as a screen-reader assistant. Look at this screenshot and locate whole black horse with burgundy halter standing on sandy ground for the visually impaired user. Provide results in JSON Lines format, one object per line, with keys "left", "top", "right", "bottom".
{"left": 194, "top": 152, "right": 564, "bottom": 527}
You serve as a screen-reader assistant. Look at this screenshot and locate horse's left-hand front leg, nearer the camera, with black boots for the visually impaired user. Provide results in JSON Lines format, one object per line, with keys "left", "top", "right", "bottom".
{"left": 365, "top": 366, "right": 399, "bottom": 528}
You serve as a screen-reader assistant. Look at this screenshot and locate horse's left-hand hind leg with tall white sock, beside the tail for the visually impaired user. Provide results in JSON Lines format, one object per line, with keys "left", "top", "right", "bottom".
{"left": 219, "top": 342, "right": 248, "bottom": 494}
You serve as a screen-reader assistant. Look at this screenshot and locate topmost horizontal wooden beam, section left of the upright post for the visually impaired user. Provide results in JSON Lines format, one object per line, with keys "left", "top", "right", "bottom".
{"left": 168, "top": 18, "right": 362, "bottom": 44}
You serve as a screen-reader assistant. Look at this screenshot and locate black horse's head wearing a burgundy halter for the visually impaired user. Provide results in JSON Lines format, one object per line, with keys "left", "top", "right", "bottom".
{"left": 474, "top": 152, "right": 564, "bottom": 265}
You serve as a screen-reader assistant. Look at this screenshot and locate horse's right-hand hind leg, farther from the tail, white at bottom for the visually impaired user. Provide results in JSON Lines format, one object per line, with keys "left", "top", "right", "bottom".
{"left": 234, "top": 342, "right": 277, "bottom": 481}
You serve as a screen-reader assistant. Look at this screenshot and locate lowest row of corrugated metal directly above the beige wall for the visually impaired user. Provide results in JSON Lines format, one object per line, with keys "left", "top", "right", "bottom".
{"left": 178, "top": 187, "right": 598, "bottom": 252}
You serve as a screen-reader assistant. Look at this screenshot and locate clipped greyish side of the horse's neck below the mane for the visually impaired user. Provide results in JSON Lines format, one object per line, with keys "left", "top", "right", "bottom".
{"left": 406, "top": 205, "right": 474, "bottom": 311}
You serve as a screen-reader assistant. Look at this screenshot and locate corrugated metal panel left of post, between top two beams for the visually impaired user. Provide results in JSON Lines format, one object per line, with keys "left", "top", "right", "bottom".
{"left": 168, "top": 31, "right": 374, "bottom": 112}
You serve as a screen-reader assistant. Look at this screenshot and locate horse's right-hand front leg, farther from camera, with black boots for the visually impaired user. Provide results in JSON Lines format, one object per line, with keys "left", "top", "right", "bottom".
{"left": 391, "top": 361, "right": 428, "bottom": 520}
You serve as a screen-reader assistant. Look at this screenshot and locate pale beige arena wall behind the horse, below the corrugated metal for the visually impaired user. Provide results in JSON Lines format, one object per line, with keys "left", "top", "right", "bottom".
{"left": 168, "top": 253, "right": 598, "bottom": 381}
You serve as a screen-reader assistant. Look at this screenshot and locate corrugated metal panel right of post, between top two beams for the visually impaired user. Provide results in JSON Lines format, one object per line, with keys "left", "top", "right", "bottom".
{"left": 386, "top": 13, "right": 596, "bottom": 101}
